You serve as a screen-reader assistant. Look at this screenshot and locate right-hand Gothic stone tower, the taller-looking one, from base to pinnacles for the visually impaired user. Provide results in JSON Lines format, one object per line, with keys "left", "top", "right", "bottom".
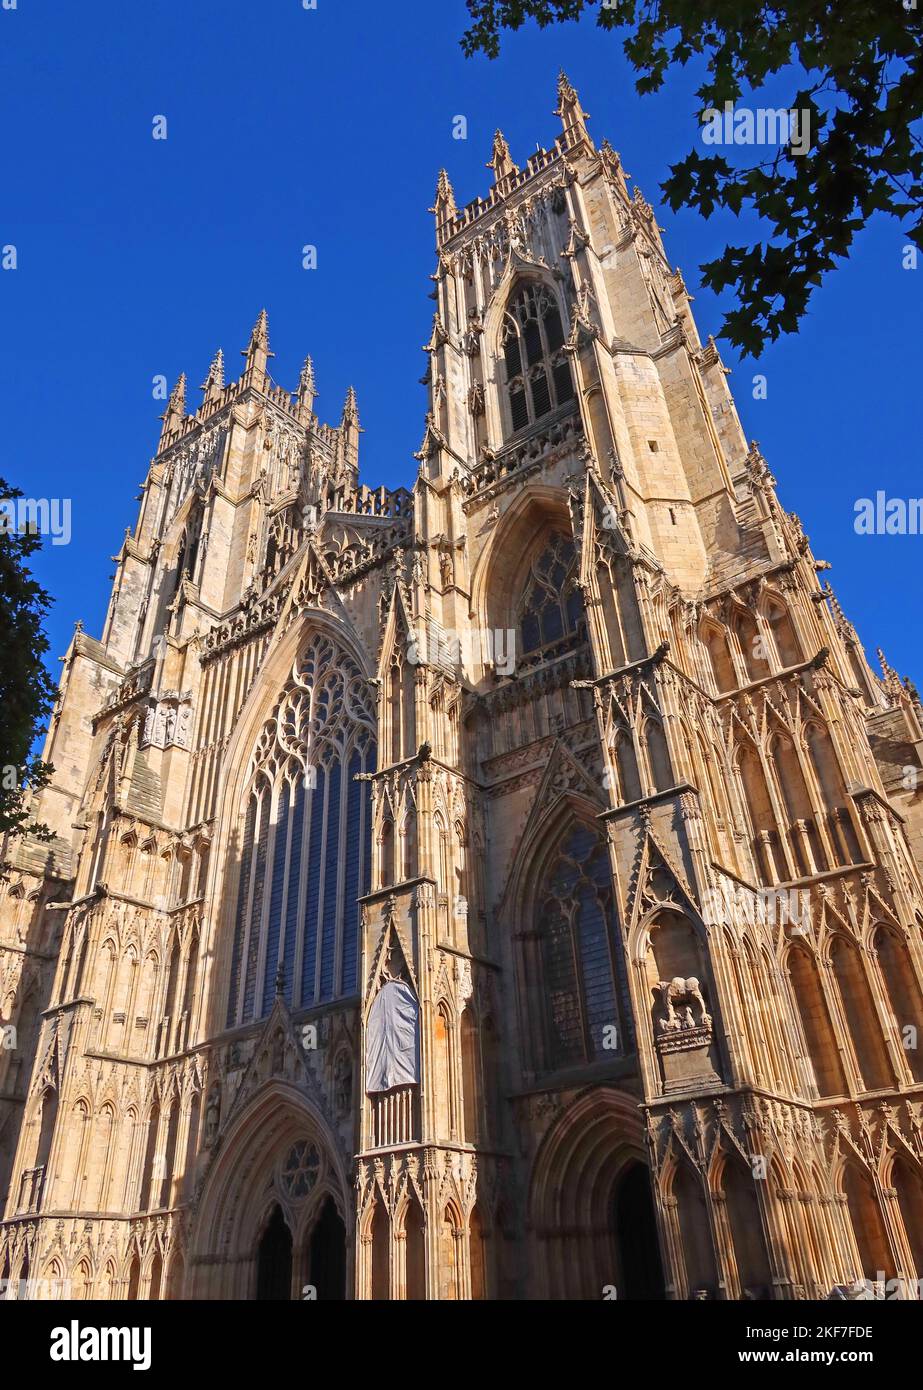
{"left": 359, "top": 74, "right": 923, "bottom": 1298}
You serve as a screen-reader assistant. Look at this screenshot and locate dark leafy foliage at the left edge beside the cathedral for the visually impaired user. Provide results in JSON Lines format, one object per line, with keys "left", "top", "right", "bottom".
{"left": 0, "top": 478, "right": 54, "bottom": 840}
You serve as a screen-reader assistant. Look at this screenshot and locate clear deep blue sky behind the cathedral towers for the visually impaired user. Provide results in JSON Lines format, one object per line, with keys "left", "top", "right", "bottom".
{"left": 0, "top": 0, "right": 923, "bottom": 700}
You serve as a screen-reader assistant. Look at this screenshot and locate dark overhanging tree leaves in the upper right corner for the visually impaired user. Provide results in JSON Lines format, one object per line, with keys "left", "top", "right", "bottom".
{"left": 462, "top": 0, "right": 923, "bottom": 356}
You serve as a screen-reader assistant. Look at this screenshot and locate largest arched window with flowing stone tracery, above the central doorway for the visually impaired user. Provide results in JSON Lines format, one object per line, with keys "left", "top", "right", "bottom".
{"left": 228, "top": 634, "right": 375, "bottom": 1027}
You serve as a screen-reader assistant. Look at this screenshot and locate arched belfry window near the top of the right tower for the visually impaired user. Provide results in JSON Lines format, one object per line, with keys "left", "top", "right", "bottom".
{"left": 500, "top": 285, "right": 574, "bottom": 431}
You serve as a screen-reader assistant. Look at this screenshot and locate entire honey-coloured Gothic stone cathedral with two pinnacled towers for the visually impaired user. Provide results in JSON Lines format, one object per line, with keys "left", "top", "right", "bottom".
{"left": 0, "top": 75, "right": 923, "bottom": 1301}
